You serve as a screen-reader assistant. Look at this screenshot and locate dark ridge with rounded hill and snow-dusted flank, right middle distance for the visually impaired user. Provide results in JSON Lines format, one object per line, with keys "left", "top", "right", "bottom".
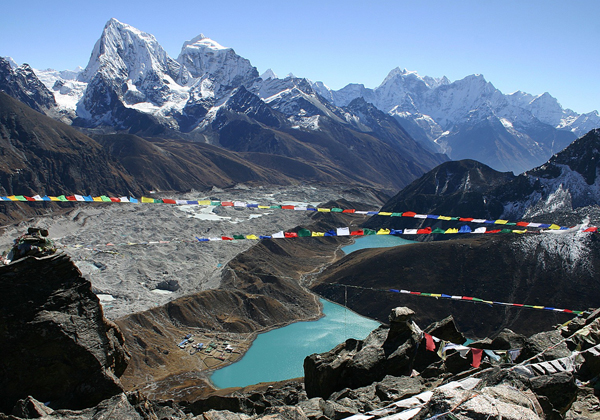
{"left": 369, "top": 129, "right": 600, "bottom": 228}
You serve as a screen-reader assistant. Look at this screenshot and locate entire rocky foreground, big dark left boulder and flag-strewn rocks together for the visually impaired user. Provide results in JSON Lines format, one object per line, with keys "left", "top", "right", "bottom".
{"left": 0, "top": 251, "right": 600, "bottom": 420}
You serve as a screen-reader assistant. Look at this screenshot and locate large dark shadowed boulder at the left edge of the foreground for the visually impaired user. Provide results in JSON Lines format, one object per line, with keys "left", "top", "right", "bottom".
{"left": 0, "top": 253, "right": 129, "bottom": 413}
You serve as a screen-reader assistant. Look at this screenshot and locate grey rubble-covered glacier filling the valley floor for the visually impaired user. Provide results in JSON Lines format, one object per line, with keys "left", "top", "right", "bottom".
{"left": 0, "top": 185, "right": 382, "bottom": 319}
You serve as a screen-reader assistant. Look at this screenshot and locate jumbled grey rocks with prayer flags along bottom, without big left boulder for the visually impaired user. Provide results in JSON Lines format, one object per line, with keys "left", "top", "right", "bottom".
{"left": 0, "top": 308, "right": 600, "bottom": 420}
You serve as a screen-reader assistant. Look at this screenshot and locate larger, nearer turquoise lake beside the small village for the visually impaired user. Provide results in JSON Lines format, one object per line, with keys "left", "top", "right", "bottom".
{"left": 211, "top": 299, "right": 379, "bottom": 388}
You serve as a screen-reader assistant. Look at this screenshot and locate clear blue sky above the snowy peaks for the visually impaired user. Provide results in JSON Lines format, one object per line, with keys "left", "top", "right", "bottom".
{"left": 0, "top": 0, "right": 600, "bottom": 113}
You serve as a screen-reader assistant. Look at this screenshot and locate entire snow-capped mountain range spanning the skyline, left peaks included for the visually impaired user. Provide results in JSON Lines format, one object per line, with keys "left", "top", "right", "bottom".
{"left": 3, "top": 19, "right": 600, "bottom": 180}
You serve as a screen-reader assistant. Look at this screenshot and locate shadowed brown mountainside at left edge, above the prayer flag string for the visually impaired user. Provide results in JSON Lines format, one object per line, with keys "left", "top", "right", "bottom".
{"left": 0, "top": 93, "right": 142, "bottom": 195}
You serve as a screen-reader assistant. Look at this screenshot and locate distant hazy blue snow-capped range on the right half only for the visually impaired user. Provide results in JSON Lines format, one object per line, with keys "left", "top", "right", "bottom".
{"left": 313, "top": 68, "right": 600, "bottom": 173}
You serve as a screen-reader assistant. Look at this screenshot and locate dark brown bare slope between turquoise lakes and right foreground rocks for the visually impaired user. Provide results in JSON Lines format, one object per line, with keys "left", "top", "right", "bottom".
{"left": 313, "top": 234, "right": 600, "bottom": 337}
